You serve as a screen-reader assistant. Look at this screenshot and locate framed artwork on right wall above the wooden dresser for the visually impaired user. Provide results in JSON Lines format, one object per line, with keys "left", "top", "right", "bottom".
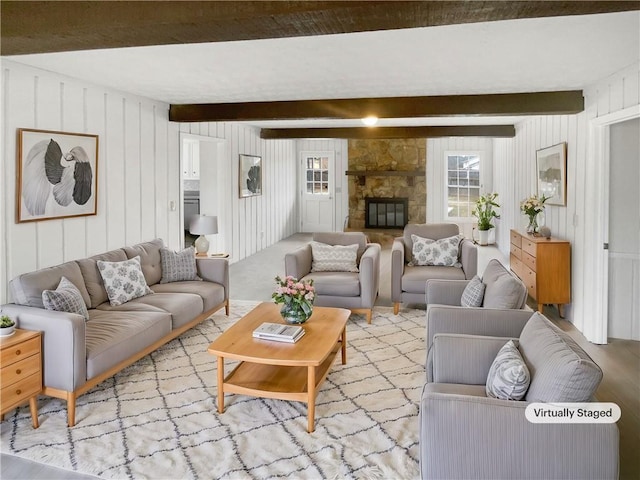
{"left": 536, "top": 142, "right": 567, "bottom": 205}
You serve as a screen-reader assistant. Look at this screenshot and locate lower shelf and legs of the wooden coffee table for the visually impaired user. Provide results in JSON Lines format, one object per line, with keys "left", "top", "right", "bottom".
{"left": 218, "top": 340, "right": 346, "bottom": 433}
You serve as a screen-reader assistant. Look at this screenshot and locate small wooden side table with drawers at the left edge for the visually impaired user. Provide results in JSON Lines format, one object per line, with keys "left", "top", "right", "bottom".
{"left": 0, "top": 328, "right": 42, "bottom": 428}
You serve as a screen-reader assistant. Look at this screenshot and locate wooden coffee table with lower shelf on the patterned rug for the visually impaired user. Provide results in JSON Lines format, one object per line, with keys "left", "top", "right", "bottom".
{"left": 208, "top": 303, "right": 351, "bottom": 433}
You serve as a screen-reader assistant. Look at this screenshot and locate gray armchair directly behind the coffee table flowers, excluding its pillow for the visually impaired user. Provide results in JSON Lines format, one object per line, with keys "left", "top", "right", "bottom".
{"left": 285, "top": 232, "right": 380, "bottom": 323}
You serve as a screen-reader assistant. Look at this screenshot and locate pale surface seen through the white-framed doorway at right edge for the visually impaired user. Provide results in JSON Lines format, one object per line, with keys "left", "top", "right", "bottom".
{"left": 608, "top": 118, "right": 640, "bottom": 340}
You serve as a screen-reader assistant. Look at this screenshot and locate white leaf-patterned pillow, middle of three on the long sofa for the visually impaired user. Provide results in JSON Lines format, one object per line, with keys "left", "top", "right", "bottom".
{"left": 96, "top": 255, "right": 153, "bottom": 307}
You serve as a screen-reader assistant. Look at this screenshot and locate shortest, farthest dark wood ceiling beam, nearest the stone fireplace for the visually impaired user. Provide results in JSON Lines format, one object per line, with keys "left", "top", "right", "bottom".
{"left": 260, "top": 125, "right": 516, "bottom": 140}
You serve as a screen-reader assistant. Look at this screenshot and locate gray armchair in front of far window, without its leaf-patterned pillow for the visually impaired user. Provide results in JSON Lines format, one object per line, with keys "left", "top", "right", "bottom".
{"left": 391, "top": 223, "right": 478, "bottom": 314}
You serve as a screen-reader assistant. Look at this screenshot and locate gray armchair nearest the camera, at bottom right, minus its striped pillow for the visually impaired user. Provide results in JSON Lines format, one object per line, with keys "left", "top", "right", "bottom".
{"left": 419, "top": 313, "right": 619, "bottom": 480}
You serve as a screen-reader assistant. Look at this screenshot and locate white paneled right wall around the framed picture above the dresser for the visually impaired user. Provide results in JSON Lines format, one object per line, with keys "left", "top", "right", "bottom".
{"left": 493, "top": 64, "right": 640, "bottom": 343}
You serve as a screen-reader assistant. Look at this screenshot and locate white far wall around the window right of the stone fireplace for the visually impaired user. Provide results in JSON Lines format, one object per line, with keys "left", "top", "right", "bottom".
{"left": 426, "top": 137, "right": 502, "bottom": 238}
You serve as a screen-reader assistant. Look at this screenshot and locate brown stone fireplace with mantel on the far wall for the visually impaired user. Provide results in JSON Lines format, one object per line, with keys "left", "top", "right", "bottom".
{"left": 347, "top": 138, "right": 427, "bottom": 243}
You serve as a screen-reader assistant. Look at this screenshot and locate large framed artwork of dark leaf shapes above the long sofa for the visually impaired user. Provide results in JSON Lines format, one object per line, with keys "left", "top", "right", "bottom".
{"left": 16, "top": 128, "right": 98, "bottom": 223}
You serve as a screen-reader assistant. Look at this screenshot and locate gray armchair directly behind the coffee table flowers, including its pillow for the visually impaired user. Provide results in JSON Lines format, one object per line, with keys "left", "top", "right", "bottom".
{"left": 285, "top": 232, "right": 380, "bottom": 323}
